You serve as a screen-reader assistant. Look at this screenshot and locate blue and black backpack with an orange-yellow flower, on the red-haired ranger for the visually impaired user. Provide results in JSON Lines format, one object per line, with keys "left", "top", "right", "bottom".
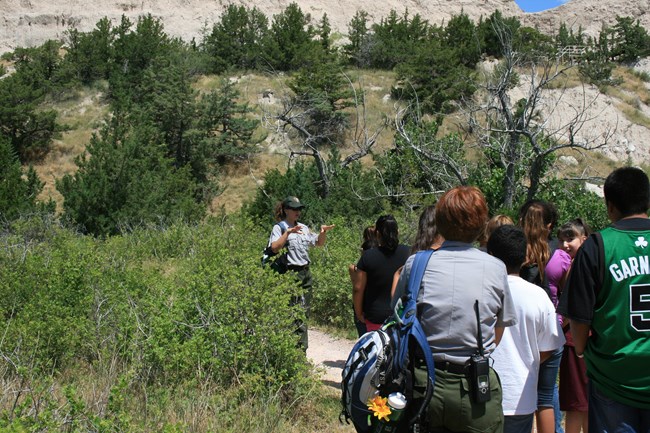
{"left": 339, "top": 250, "right": 435, "bottom": 433}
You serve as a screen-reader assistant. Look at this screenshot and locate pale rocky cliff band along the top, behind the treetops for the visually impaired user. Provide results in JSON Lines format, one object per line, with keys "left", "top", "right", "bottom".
{"left": 0, "top": 0, "right": 650, "bottom": 54}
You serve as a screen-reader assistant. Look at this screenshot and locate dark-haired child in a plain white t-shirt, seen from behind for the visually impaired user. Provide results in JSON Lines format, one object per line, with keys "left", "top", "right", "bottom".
{"left": 487, "top": 225, "right": 564, "bottom": 433}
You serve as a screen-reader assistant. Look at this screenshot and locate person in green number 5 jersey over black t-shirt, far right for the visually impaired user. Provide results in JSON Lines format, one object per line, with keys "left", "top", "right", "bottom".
{"left": 558, "top": 167, "right": 650, "bottom": 433}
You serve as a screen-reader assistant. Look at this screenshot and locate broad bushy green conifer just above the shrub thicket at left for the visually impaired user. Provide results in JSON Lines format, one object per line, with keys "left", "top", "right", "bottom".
{"left": 56, "top": 116, "right": 205, "bottom": 236}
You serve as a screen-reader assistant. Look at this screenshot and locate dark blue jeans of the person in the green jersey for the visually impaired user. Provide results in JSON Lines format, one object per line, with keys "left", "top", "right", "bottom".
{"left": 589, "top": 382, "right": 650, "bottom": 433}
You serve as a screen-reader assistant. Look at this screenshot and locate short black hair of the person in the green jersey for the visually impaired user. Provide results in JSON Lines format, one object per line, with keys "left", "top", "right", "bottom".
{"left": 603, "top": 167, "right": 650, "bottom": 217}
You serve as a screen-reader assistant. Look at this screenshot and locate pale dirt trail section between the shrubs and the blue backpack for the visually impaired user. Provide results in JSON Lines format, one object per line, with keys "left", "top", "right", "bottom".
{"left": 307, "top": 328, "right": 354, "bottom": 390}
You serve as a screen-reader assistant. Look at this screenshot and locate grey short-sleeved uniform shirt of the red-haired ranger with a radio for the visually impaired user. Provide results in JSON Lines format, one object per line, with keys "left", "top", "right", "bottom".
{"left": 394, "top": 241, "right": 516, "bottom": 364}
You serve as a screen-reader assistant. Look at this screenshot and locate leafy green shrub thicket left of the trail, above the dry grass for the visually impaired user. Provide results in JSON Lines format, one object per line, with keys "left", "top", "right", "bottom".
{"left": 0, "top": 216, "right": 306, "bottom": 389}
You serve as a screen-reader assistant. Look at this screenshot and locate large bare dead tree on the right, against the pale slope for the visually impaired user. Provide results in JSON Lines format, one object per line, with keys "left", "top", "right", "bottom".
{"left": 461, "top": 21, "right": 616, "bottom": 208}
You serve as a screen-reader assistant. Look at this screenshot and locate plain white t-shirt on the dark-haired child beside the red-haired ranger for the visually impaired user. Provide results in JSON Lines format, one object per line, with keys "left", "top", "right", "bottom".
{"left": 492, "top": 275, "right": 564, "bottom": 416}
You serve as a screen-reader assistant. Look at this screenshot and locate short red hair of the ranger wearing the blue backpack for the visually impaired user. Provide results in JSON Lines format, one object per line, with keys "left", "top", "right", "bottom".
{"left": 436, "top": 186, "right": 488, "bottom": 243}
